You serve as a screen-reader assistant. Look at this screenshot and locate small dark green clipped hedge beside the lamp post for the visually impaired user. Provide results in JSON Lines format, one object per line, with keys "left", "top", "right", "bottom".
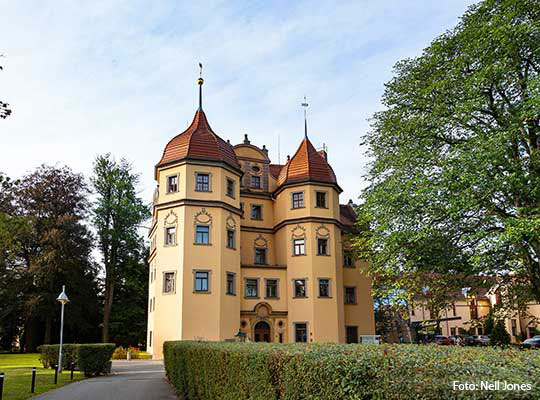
{"left": 38, "top": 343, "right": 116, "bottom": 376}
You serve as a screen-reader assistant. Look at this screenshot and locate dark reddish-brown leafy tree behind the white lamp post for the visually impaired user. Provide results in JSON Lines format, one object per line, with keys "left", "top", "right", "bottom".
{"left": 0, "top": 166, "right": 98, "bottom": 351}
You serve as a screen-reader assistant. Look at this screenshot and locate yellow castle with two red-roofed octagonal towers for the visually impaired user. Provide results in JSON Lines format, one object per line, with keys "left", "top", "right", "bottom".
{"left": 147, "top": 78, "right": 375, "bottom": 359}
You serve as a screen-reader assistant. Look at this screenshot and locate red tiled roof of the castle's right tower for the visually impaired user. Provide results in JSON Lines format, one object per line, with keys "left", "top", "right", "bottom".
{"left": 278, "top": 138, "right": 337, "bottom": 186}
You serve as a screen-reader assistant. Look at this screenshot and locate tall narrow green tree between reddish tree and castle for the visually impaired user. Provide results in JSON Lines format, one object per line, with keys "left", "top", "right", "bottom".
{"left": 92, "top": 154, "right": 150, "bottom": 342}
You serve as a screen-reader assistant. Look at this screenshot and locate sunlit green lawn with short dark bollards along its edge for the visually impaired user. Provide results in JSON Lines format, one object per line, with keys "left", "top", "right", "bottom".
{"left": 0, "top": 354, "right": 84, "bottom": 400}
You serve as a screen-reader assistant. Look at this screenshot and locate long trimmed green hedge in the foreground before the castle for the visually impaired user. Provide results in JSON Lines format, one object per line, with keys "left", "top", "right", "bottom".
{"left": 164, "top": 341, "right": 540, "bottom": 400}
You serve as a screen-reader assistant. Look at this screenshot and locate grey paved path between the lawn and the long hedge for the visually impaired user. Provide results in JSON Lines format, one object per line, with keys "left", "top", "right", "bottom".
{"left": 32, "top": 360, "right": 177, "bottom": 400}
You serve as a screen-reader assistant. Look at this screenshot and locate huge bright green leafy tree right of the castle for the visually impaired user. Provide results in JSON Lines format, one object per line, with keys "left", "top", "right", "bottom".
{"left": 356, "top": 0, "right": 540, "bottom": 301}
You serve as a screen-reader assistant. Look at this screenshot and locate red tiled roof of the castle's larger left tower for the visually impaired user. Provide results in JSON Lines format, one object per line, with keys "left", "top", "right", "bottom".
{"left": 157, "top": 110, "right": 240, "bottom": 169}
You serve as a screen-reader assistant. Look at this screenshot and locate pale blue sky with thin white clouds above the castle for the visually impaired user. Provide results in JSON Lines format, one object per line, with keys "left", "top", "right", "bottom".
{"left": 0, "top": 0, "right": 474, "bottom": 203}
